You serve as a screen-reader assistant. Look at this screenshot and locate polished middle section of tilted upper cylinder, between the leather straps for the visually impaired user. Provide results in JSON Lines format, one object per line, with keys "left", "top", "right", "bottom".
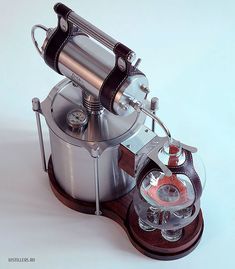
{"left": 58, "top": 35, "right": 115, "bottom": 98}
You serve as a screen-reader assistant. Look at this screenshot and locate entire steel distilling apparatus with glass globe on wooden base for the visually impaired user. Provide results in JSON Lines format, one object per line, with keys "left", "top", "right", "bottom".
{"left": 31, "top": 3, "right": 205, "bottom": 260}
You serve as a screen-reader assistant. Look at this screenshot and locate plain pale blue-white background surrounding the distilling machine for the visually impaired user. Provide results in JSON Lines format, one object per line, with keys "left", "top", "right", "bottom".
{"left": 0, "top": 0, "right": 235, "bottom": 269}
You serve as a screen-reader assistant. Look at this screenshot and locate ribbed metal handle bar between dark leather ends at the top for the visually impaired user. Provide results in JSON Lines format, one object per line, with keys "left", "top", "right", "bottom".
{"left": 68, "top": 12, "right": 118, "bottom": 50}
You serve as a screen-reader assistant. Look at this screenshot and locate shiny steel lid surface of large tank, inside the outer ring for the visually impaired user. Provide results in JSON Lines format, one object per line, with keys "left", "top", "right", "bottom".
{"left": 51, "top": 80, "right": 144, "bottom": 142}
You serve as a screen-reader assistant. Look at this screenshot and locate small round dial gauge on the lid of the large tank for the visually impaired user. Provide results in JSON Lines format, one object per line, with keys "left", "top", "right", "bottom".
{"left": 67, "top": 107, "right": 88, "bottom": 131}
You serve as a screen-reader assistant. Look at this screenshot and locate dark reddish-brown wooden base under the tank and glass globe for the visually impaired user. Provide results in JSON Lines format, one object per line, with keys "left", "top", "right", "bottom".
{"left": 48, "top": 158, "right": 204, "bottom": 260}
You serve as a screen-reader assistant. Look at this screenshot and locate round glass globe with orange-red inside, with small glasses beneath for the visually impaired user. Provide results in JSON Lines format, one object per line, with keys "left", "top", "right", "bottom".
{"left": 134, "top": 140, "right": 205, "bottom": 241}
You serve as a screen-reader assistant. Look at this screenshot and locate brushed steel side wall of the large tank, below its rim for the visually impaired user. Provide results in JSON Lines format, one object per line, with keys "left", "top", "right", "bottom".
{"left": 50, "top": 131, "right": 135, "bottom": 202}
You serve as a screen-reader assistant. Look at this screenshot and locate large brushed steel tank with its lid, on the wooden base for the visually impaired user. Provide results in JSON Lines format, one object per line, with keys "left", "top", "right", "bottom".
{"left": 41, "top": 79, "right": 145, "bottom": 202}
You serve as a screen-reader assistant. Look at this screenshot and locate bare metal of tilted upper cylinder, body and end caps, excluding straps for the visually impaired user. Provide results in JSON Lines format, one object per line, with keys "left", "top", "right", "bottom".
{"left": 38, "top": 29, "right": 148, "bottom": 116}
